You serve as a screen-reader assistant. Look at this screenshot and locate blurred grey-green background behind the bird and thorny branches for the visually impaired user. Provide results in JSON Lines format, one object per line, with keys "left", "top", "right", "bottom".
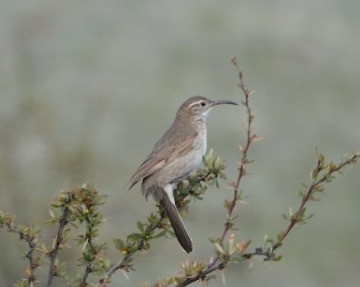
{"left": 0, "top": 0, "right": 360, "bottom": 287}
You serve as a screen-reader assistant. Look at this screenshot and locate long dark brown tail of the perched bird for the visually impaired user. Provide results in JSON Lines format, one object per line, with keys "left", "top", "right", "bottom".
{"left": 160, "top": 193, "right": 193, "bottom": 253}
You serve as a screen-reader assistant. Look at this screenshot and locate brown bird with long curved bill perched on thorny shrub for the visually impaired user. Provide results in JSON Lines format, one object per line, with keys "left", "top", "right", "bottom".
{"left": 129, "top": 96, "right": 237, "bottom": 253}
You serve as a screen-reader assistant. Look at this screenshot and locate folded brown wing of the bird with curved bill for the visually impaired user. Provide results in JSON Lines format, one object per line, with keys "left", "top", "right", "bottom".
{"left": 129, "top": 129, "right": 193, "bottom": 188}
